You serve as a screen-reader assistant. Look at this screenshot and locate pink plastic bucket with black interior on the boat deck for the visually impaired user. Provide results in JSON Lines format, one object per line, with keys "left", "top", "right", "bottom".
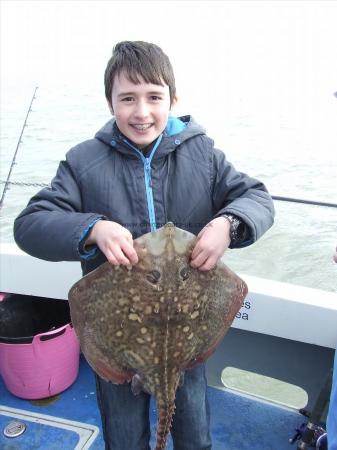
{"left": 0, "top": 296, "right": 80, "bottom": 399}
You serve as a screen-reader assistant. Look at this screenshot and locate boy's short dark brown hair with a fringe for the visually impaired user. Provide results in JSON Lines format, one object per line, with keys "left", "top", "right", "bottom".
{"left": 104, "top": 41, "right": 176, "bottom": 105}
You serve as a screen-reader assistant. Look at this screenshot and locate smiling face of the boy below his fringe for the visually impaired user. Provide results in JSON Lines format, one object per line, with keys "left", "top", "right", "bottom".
{"left": 111, "top": 72, "right": 175, "bottom": 148}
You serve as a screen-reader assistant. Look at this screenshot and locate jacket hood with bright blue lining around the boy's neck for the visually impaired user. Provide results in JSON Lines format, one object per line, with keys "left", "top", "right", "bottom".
{"left": 95, "top": 116, "right": 206, "bottom": 155}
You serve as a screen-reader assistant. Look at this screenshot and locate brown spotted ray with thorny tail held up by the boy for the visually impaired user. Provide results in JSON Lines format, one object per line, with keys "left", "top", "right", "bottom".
{"left": 69, "top": 224, "right": 247, "bottom": 450}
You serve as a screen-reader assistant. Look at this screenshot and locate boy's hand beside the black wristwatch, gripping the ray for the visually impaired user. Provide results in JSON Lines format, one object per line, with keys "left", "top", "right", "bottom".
{"left": 191, "top": 217, "right": 231, "bottom": 271}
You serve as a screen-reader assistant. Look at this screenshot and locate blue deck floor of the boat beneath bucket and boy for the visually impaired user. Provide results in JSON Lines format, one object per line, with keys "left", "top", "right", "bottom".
{"left": 0, "top": 360, "right": 304, "bottom": 450}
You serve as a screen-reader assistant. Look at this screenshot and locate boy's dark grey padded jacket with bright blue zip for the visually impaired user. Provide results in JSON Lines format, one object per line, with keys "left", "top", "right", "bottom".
{"left": 14, "top": 116, "right": 274, "bottom": 273}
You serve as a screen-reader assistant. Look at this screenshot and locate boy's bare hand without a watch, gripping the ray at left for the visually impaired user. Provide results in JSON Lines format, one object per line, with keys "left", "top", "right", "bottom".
{"left": 85, "top": 220, "right": 138, "bottom": 266}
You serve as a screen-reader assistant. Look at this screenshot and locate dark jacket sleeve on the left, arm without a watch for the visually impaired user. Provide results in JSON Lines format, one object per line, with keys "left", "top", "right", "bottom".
{"left": 14, "top": 156, "right": 105, "bottom": 261}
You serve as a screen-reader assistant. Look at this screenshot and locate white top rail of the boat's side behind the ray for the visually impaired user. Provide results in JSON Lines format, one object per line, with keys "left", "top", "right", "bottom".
{"left": 0, "top": 244, "right": 337, "bottom": 348}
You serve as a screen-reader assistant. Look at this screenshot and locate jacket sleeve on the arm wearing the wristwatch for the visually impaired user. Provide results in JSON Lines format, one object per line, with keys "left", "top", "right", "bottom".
{"left": 212, "top": 149, "right": 275, "bottom": 247}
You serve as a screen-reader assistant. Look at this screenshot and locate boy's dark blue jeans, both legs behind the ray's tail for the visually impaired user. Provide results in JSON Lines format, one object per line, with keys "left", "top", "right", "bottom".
{"left": 96, "top": 365, "right": 211, "bottom": 450}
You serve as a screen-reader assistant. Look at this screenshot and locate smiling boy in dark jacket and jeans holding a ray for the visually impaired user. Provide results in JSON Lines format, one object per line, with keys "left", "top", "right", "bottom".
{"left": 14, "top": 41, "right": 274, "bottom": 450}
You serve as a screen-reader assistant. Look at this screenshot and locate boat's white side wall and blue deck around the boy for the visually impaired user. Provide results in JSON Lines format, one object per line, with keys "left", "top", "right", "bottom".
{"left": 0, "top": 248, "right": 337, "bottom": 450}
